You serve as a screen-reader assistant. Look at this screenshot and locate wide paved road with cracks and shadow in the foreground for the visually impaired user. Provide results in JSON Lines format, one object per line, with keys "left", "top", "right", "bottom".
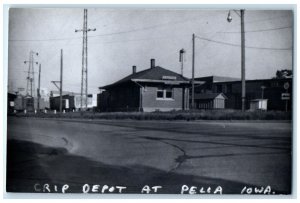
{"left": 7, "top": 117, "right": 292, "bottom": 194}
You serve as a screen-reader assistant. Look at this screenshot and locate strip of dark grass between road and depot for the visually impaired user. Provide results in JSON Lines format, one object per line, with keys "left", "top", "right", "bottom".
{"left": 13, "top": 109, "right": 292, "bottom": 121}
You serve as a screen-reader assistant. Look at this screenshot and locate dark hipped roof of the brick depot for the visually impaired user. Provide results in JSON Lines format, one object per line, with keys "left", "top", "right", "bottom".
{"left": 100, "top": 66, "right": 189, "bottom": 89}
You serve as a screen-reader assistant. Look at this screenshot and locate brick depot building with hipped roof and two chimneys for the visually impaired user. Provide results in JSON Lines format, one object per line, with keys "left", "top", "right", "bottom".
{"left": 98, "top": 59, "right": 191, "bottom": 112}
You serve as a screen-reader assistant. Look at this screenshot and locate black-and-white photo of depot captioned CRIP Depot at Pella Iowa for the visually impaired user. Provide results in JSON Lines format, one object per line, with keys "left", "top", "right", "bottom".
{"left": 4, "top": 5, "right": 296, "bottom": 198}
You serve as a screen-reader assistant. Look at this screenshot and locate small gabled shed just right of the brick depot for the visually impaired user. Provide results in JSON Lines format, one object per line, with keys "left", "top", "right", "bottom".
{"left": 195, "top": 93, "right": 227, "bottom": 109}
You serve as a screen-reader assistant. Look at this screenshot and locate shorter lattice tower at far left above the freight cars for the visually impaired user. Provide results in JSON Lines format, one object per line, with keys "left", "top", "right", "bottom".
{"left": 24, "top": 51, "right": 39, "bottom": 97}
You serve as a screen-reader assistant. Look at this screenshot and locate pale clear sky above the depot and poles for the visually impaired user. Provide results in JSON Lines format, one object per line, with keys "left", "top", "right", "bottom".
{"left": 8, "top": 8, "right": 293, "bottom": 93}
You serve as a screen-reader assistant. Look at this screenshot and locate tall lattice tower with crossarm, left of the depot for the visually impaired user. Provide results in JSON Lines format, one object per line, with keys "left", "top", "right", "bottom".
{"left": 75, "top": 9, "right": 96, "bottom": 111}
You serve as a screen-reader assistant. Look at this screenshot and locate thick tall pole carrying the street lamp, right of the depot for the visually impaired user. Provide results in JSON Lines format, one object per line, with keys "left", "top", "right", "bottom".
{"left": 241, "top": 9, "right": 246, "bottom": 112}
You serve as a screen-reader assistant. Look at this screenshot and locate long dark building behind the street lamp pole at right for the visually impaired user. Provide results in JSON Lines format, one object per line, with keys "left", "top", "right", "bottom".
{"left": 195, "top": 76, "right": 292, "bottom": 111}
